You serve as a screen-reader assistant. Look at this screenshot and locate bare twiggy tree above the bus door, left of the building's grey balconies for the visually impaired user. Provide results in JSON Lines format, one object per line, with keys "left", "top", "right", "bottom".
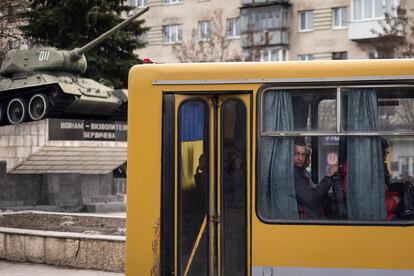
{"left": 172, "top": 9, "right": 241, "bottom": 62}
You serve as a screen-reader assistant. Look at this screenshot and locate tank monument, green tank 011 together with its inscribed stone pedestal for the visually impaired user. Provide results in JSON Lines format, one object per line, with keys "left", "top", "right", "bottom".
{"left": 0, "top": 8, "right": 148, "bottom": 212}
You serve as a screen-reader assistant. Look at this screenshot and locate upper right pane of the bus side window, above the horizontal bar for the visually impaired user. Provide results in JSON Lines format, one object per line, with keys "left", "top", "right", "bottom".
{"left": 342, "top": 87, "right": 414, "bottom": 131}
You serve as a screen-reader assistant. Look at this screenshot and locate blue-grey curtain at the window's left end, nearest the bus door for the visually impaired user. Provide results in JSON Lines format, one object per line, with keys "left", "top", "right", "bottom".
{"left": 259, "top": 91, "right": 298, "bottom": 219}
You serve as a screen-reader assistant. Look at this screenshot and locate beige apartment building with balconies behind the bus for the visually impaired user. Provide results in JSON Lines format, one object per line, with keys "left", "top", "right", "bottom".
{"left": 129, "top": 0, "right": 414, "bottom": 63}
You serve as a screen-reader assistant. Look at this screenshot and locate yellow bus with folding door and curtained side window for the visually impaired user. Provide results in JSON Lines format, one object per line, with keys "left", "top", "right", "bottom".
{"left": 126, "top": 59, "right": 414, "bottom": 276}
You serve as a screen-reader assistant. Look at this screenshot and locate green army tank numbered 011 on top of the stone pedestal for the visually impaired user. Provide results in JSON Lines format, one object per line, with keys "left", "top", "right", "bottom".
{"left": 0, "top": 7, "right": 149, "bottom": 125}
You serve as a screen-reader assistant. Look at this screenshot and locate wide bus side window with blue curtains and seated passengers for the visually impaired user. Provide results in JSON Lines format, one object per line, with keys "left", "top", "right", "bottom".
{"left": 258, "top": 86, "right": 414, "bottom": 221}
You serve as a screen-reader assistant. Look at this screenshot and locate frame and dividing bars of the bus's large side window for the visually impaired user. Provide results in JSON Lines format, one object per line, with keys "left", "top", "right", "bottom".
{"left": 254, "top": 79, "right": 414, "bottom": 227}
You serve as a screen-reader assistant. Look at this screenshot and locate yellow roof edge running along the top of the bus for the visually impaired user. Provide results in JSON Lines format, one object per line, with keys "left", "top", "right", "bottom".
{"left": 130, "top": 59, "right": 414, "bottom": 85}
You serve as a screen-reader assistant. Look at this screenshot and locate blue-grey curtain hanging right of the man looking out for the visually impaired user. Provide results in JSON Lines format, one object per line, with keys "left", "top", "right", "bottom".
{"left": 346, "top": 89, "right": 386, "bottom": 220}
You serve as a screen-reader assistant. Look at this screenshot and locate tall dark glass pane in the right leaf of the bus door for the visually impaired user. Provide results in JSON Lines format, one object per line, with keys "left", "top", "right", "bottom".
{"left": 221, "top": 100, "right": 247, "bottom": 276}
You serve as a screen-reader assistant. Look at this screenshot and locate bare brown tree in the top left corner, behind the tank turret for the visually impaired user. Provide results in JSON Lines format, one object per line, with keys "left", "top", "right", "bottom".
{"left": 0, "top": 0, "right": 28, "bottom": 60}
